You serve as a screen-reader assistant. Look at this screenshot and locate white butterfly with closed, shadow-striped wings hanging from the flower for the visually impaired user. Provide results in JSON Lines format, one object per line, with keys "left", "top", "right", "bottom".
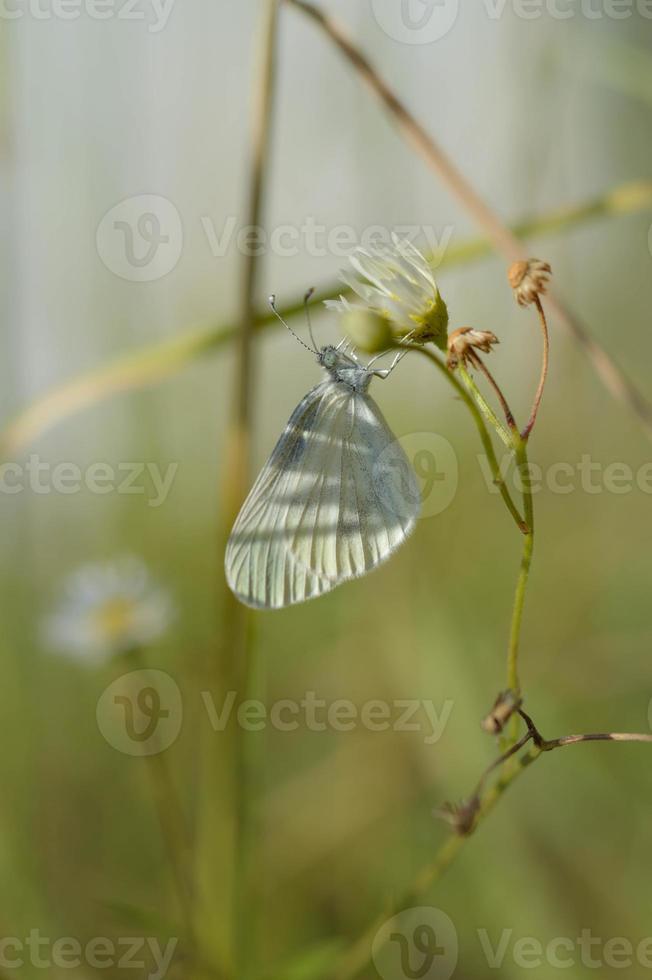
{"left": 225, "top": 297, "right": 421, "bottom": 609}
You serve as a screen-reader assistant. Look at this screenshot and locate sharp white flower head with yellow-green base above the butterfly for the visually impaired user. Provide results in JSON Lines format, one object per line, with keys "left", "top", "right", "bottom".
{"left": 326, "top": 235, "right": 448, "bottom": 350}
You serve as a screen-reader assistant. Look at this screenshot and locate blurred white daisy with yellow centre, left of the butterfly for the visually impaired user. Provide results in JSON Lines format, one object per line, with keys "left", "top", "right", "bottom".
{"left": 43, "top": 556, "right": 174, "bottom": 662}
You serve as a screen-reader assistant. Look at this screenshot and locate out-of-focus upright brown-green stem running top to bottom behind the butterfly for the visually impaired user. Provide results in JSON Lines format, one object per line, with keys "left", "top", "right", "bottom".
{"left": 197, "top": 0, "right": 280, "bottom": 980}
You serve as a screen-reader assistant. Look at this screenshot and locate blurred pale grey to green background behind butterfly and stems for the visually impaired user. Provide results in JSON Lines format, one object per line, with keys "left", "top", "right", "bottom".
{"left": 0, "top": 0, "right": 652, "bottom": 980}
